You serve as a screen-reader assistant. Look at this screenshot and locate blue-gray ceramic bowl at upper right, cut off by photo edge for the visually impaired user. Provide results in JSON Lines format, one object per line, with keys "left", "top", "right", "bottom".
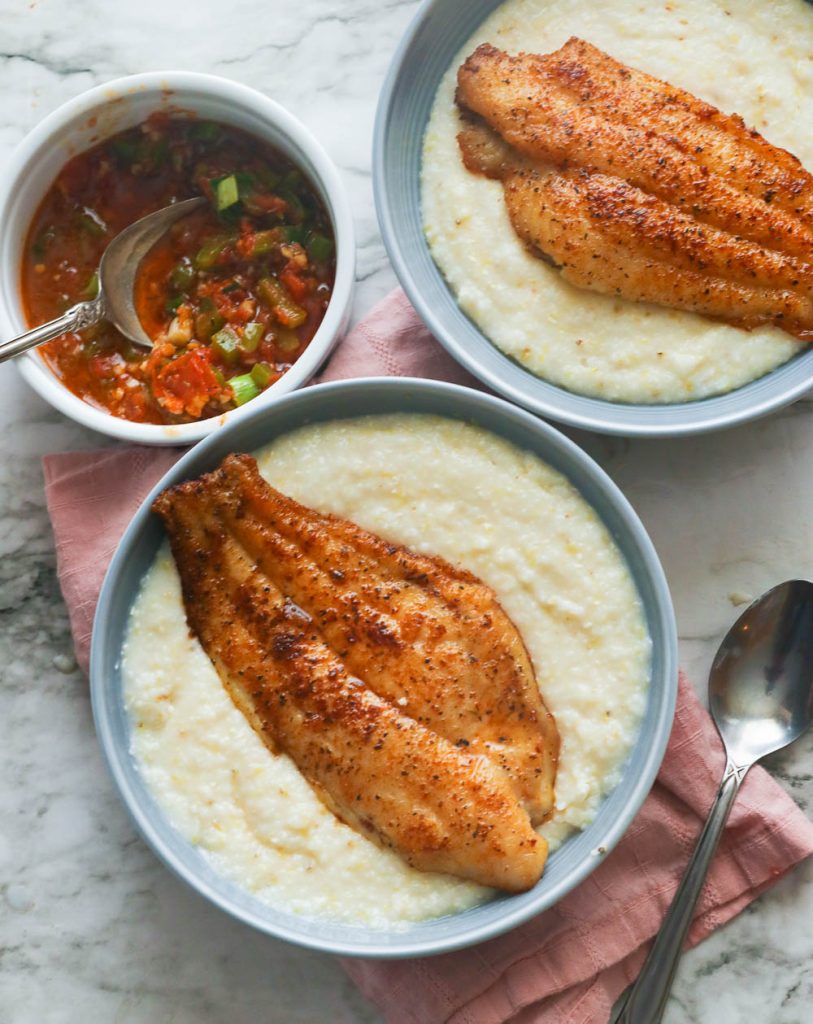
{"left": 373, "top": 0, "right": 813, "bottom": 437}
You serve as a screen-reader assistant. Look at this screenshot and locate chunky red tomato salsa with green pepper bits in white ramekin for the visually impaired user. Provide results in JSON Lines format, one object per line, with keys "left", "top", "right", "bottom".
{"left": 23, "top": 108, "right": 335, "bottom": 424}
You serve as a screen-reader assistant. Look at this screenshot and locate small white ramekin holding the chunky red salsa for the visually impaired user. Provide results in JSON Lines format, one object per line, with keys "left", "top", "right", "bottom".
{"left": 0, "top": 71, "right": 355, "bottom": 444}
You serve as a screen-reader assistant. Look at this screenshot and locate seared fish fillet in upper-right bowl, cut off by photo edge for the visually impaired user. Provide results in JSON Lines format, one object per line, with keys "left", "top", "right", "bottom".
{"left": 458, "top": 39, "right": 813, "bottom": 339}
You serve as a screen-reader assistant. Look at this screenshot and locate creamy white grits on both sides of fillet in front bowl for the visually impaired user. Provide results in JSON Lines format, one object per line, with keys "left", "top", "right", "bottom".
{"left": 123, "top": 415, "right": 649, "bottom": 928}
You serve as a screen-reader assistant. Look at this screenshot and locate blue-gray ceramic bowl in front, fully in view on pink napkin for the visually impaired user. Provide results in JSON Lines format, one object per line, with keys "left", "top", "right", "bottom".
{"left": 90, "top": 378, "right": 677, "bottom": 956}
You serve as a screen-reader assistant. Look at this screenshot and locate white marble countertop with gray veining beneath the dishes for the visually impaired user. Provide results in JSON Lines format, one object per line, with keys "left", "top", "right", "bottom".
{"left": 0, "top": 0, "right": 813, "bottom": 1024}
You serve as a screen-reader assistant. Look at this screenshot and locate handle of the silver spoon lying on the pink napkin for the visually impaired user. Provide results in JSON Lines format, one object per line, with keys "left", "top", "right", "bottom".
{"left": 609, "top": 760, "right": 751, "bottom": 1024}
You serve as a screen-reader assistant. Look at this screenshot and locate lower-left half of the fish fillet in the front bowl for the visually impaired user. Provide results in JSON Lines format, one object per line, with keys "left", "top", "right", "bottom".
{"left": 154, "top": 457, "right": 547, "bottom": 892}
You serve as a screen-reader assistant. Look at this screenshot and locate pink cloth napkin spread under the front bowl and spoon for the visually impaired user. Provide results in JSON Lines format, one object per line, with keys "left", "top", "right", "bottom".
{"left": 44, "top": 292, "right": 813, "bottom": 1024}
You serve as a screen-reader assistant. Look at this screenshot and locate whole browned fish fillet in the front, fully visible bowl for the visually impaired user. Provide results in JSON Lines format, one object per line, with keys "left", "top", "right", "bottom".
{"left": 155, "top": 456, "right": 558, "bottom": 891}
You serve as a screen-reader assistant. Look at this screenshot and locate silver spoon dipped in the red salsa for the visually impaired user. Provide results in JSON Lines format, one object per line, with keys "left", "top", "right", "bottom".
{"left": 0, "top": 196, "right": 207, "bottom": 362}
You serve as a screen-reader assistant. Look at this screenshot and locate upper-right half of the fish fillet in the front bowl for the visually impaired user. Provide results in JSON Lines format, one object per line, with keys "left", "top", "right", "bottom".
{"left": 215, "top": 458, "right": 559, "bottom": 824}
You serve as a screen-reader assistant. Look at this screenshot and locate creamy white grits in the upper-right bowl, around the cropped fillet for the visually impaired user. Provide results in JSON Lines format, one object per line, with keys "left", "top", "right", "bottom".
{"left": 422, "top": 0, "right": 813, "bottom": 403}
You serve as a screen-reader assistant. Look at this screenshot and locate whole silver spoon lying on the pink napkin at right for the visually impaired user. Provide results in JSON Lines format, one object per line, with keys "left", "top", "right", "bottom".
{"left": 609, "top": 580, "right": 813, "bottom": 1024}
